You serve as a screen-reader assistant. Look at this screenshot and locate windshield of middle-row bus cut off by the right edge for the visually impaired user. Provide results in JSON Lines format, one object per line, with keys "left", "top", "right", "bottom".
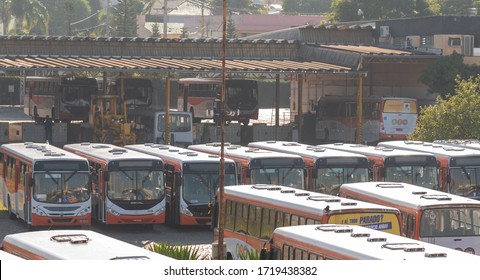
{"left": 450, "top": 167, "right": 480, "bottom": 197}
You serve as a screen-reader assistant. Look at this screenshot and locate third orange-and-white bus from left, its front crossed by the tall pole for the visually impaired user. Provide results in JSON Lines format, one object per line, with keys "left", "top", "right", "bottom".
{"left": 125, "top": 143, "right": 237, "bottom": 225}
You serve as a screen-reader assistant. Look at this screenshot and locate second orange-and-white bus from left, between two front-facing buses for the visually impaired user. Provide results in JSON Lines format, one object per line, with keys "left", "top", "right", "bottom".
{"left": 63, "top": 143, "right": 165, "bottom": 226}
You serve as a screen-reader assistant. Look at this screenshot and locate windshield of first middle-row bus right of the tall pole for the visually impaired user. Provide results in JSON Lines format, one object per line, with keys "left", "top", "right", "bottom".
{"left": 251, "top": 167, "right": 305, "bottom": 190}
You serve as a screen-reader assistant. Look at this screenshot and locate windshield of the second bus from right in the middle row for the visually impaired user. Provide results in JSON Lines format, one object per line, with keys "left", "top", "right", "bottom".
{"left": 385, "top": 166, "right": 439, "bottom": 189}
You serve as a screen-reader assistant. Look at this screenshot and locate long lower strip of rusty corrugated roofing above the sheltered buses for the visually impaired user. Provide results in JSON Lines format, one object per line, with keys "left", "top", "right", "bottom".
{"left": 0, "top": 56, "right": 352, "bottom": 74}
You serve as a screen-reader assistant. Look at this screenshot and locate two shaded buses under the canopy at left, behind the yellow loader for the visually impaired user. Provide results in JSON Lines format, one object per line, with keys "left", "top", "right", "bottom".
{"left": 23, "top": 76, "right": 153, "bottom": 122}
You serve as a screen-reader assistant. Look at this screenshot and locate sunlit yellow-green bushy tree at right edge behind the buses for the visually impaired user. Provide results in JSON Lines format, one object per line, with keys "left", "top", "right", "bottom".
{"left": 409, "top": 75, "right": 480, "bottom": 142}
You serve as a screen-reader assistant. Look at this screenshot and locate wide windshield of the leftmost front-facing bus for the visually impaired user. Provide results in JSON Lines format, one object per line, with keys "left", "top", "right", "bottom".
{"left": 33, "top": 171, "right": 90, "bottom": 204}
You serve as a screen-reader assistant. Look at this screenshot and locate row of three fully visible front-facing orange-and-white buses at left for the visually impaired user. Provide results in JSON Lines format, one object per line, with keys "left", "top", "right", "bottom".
{"left": 0, "top": 143, "right": 238, "bottom": 226}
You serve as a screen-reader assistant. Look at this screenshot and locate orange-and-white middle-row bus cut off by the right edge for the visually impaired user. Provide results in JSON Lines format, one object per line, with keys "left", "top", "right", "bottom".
{"left": 378, "top": 141, "right": 480, "bottom": 199}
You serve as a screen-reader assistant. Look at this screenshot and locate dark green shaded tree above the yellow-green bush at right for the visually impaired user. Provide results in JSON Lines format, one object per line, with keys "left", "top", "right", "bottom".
{"left": 420, "top": 52, "right": 480, "bottom": 97}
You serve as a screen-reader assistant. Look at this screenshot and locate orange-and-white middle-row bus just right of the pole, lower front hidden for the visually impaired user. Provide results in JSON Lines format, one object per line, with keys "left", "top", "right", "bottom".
{"left": 188, "top": 142, "right": 306, "bottom": 190}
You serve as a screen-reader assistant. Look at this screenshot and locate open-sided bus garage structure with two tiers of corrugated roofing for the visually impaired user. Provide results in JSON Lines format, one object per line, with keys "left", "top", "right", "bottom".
{"left": 0, "top": 36, "right": 436, "bottom": 142}
